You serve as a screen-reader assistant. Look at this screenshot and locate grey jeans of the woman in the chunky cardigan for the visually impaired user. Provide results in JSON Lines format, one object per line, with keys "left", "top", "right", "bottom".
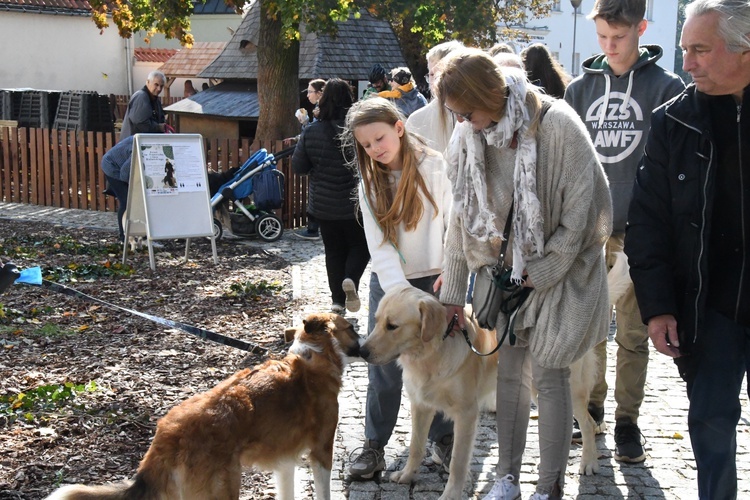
{"left": 497, "top": 344, "right": 573, "bottom": 498}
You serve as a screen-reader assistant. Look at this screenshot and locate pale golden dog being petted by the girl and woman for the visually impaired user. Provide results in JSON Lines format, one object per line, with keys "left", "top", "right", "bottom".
{"left": 361, "top": 287, "right": 498, "bottom": 499}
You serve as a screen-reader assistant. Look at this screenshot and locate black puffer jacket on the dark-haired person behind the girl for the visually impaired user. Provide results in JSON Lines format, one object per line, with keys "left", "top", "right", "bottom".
{"left": 292, "top": 120, "right": 358, "bottom": 220}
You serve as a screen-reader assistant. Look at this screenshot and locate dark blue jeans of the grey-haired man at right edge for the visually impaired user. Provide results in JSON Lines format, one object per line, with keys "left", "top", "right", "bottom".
{"left": 687, "top": 309, "right": 750, "bottom": 500}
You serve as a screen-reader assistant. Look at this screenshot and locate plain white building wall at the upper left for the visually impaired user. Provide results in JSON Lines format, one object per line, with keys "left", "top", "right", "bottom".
{"left": 0, "top": 12, "right": 128, "bottom": 94}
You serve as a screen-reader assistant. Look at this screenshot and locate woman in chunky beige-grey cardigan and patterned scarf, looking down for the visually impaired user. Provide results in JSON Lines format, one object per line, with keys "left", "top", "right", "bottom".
{"left": 437, "top": 49, "right": 612, "bottom": 500}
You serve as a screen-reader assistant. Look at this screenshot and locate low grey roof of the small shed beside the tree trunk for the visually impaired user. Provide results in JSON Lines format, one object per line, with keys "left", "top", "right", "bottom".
{"left": 164, "top": 82, "right": 260, "bottom": 119}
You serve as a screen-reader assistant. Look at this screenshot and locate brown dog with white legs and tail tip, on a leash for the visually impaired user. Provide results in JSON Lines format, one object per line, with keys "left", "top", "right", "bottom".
{"left": 48, "top": 313, "right": 360, "bottom": 500}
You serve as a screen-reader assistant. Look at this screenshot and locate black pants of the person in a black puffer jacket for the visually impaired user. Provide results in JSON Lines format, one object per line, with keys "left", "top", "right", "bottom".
{"left": 317, "top": 219, "right": 370, "bottom": 306}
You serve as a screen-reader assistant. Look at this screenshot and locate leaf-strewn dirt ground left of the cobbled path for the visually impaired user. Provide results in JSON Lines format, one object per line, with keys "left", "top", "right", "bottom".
{"left": 0, "top": 221, "right": 298, "bottom": 499}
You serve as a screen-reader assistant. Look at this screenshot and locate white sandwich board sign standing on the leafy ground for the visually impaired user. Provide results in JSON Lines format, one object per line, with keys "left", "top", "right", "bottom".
{"left": 122, "top": 134, "right": 219, "bottom": 271}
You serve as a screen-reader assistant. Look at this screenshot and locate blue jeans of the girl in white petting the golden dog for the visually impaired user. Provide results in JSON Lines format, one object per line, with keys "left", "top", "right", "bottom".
{"left": 365, "top": 273, "right": 453, "bottom": 448}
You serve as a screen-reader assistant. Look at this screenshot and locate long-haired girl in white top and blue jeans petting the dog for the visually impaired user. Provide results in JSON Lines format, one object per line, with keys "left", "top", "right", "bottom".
{"left": 345, "top": 97, "right": 453, "bottom": 480}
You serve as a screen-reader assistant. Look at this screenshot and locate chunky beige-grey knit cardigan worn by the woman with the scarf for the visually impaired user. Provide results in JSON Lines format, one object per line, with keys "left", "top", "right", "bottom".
{"left": 440, "top": 101, "right": 612, "bottom": 368}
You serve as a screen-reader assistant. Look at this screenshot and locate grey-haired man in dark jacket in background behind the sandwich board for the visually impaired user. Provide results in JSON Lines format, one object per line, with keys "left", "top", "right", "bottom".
{"left": 120, "top": 71, "right": 167, "bottom": 140}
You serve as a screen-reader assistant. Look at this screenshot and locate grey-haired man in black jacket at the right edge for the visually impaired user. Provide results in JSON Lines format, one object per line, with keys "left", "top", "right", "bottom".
{"left": 625, "top": 0, "right": 750, "bottom": 499}
